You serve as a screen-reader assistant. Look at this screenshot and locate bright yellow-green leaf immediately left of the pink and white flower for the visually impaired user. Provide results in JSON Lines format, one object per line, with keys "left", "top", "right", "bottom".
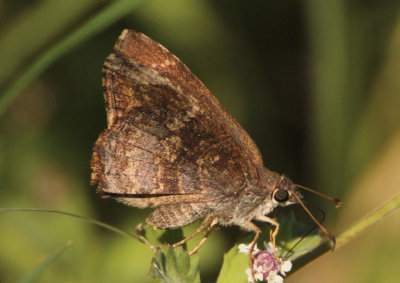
{"left": 217, "top": 245, "right": 250, "bottom": 283}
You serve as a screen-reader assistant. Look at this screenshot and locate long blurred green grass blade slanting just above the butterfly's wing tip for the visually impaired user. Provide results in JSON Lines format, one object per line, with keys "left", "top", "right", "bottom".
{"left": 0, "top": 0, "right": 142, "bottom": 116}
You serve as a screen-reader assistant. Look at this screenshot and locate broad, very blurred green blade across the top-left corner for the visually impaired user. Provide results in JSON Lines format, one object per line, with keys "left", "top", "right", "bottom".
{"left": 0, "top": 0, "right": 101, "bottom": 85}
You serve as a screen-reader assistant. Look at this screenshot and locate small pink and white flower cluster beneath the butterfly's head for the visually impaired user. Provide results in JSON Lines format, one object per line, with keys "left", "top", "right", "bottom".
{"left": 239, "top": 243, "right": 292, "bottom": 283}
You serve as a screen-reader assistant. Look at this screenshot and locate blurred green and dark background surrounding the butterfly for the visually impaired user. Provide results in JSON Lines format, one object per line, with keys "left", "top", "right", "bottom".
{"left": 0, "top": 0, "right": 400, "bottom": 282}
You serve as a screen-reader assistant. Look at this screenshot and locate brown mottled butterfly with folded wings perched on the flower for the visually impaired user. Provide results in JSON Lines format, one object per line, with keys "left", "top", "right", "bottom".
{"left": 91, "top": 30, "right": 338, "bottom": 254}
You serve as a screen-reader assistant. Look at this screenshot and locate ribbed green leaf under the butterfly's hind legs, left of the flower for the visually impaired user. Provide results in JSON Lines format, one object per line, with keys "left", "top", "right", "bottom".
{"left": 150, "top": 245, "right": 200, "bottom": 283}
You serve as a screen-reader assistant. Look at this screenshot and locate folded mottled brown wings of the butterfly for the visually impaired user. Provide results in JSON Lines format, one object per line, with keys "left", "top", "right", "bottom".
{"left": 92, "top": 30, "right": 262, "bottom": 207}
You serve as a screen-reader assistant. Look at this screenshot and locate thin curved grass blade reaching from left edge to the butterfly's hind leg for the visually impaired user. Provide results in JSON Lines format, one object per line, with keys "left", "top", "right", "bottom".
{"left": 0, "top": 208, "right": 141, "bottom": 241}
